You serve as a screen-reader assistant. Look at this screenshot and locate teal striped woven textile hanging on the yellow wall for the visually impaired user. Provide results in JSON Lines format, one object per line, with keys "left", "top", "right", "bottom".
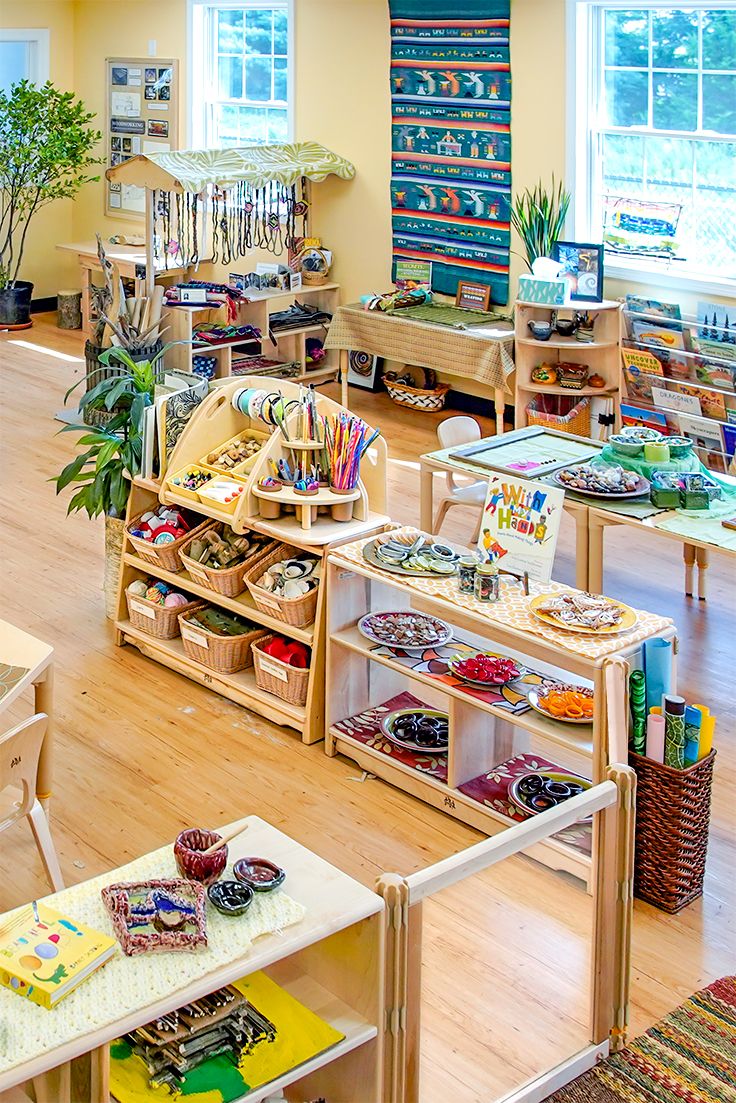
{"left": 390, "top": 0, "right": 511, "bottom": 303}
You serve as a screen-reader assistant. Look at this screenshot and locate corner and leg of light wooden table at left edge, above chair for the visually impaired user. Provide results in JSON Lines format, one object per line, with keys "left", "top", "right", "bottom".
{"left": 0, "top": 620, "right": 54, "bottom": 816}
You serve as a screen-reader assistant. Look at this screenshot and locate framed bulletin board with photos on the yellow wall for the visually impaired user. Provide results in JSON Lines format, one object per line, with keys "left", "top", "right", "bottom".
{"left": 105, "top": 57, "right": 179, "bottom": 218}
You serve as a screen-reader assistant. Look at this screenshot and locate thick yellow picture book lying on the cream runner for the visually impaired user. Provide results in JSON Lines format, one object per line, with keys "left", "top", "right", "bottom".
{"left": 0, "top": 903, "right": 117, "bottom": 1009}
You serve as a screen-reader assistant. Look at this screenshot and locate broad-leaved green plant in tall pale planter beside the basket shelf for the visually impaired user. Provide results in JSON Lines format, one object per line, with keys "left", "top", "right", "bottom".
{"left": 52, "top": 344, "right": 171, "bottom": 619}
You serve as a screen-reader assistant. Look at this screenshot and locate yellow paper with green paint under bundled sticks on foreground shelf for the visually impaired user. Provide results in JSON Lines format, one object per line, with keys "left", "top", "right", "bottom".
{"left": 110, "top": 973, "right": 344, "bottom": 1103}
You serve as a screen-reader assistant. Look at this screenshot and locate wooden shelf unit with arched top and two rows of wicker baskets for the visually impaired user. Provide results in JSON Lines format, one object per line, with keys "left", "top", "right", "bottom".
{"left": 116, "top": 376, "right": 388, "bottom": 743}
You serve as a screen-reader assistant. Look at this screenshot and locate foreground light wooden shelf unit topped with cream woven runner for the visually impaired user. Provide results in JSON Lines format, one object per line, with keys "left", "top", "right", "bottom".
{"left": 0, "top": 816, "right": 384, "bottom": 1103}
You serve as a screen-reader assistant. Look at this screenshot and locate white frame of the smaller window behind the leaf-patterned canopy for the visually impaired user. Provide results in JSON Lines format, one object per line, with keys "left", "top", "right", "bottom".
{"left": 186, "top": 0, "right": 296, "bottom": 149}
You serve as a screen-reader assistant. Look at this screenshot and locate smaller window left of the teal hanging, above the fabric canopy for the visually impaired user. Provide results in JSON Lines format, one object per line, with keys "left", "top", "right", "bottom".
{"left": 190, "top": 0, "right": 291, "bottom": 149}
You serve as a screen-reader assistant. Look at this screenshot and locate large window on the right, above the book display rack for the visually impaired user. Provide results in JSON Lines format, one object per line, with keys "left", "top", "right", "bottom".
{"left": 574, "top": 0, "right": 736, "bottom": 279}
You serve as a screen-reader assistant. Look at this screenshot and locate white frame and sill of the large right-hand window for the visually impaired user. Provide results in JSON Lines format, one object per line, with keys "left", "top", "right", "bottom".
{"left": 566, "top": 0, "right": 736, "bottom": 296}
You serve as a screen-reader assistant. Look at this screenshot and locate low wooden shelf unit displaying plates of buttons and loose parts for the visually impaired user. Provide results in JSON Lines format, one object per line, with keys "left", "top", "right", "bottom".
{"left": 326, "top": 533, "right": 674, "bottom": 885}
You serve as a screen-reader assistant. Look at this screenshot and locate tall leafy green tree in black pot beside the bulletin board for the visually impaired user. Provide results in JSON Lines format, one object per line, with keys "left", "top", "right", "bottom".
{"left": 0, "top": 81, "right": 102, "bottom": 325}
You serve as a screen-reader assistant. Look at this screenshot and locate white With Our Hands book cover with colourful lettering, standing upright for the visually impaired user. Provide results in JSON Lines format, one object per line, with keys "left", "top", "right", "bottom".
{"left": 478, "top": 475, "right": 565, "bottom": 582}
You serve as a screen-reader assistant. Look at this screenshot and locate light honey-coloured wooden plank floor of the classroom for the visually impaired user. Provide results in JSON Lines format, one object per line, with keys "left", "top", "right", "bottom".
{"left": 0, "top": 315, "right": 736, "bottom": 1103}
